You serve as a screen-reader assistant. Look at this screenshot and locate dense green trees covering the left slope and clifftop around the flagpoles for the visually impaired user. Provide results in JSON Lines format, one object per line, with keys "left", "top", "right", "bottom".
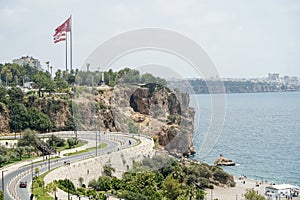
{"left": 0, "top": 63, "right": 166, "bottom": 132}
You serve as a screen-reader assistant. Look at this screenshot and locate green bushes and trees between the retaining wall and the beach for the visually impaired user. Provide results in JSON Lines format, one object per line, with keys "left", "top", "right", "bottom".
{"left": 55, "top": 156, "right": 234, "bottom": 200}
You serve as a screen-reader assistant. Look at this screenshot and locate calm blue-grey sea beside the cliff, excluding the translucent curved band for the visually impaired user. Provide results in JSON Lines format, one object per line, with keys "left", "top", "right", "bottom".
{"left": 191, "top": 92, "right": 300, "bottom": 186}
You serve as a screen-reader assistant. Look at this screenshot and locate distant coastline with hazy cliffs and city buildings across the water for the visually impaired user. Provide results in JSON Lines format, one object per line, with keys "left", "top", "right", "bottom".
{"left": 168, "top": 74, "right": 300, "bottom": 94}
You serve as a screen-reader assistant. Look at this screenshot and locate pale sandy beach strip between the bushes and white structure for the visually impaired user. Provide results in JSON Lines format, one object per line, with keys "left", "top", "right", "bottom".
{"left": 205, "top": 177, "right": 300, "bottom": 200}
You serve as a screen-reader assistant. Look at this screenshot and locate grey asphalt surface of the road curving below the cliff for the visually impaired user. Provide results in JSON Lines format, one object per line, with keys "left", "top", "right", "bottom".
{"left": 1, "top": 133, "right": 137, "bottom": 200}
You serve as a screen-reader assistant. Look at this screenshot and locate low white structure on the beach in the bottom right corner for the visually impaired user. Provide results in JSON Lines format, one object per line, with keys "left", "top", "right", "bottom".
{"left": 265, "top": 184, "right": 299, "bottom": 200}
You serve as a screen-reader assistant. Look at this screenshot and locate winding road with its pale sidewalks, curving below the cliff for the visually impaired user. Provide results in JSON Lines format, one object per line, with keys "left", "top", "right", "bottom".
{"left": 1, "top": 132, "right": 138, "bottom": 200}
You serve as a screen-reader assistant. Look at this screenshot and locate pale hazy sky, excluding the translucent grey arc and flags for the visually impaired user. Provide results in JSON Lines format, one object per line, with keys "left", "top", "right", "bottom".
{"left": 0, "top": 0, "right": 300, "bottom": 78}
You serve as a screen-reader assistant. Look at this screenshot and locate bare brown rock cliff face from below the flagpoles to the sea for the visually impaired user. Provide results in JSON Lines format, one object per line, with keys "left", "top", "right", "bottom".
{"left": 73, "top": 84, "right": 195, "bottom": 155}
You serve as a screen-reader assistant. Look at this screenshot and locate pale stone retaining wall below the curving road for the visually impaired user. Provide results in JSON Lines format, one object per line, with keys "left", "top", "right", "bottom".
{"left": 44, "top": 134, "right": 154, "bottom": 200}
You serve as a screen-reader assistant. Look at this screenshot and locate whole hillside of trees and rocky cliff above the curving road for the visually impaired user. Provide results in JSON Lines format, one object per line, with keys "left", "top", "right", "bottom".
{"left": 0, "top": 64, "right": 194, "bottom": 156}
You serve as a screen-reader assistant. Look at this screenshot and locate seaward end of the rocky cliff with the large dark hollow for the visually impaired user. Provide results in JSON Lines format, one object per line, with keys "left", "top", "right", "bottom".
{"left": 130, "top": 84, "right": 195, "bottom": 154}
